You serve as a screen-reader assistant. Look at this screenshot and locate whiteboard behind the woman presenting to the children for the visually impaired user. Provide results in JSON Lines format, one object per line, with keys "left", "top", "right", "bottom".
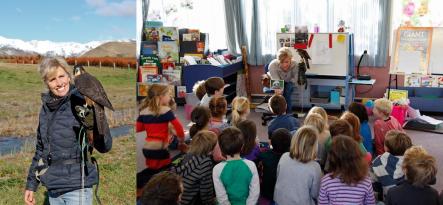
{"left": 277, "top": 33, "right": 350, "bottom": 76}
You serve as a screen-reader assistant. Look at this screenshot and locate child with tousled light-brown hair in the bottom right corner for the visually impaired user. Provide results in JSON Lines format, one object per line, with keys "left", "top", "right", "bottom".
{"left": 385, "top": 146, "right": 439, "bottom": 205}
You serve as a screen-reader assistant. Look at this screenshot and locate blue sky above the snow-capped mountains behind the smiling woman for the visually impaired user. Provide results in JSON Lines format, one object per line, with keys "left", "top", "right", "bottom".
{"left": 0, "top": 0, "right": 136, "bottom": 43}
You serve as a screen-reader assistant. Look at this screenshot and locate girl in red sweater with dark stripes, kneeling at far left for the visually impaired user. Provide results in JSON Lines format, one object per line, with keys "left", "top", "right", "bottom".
{"left": 136, "top": 84, "right": 185, "bottom": 170}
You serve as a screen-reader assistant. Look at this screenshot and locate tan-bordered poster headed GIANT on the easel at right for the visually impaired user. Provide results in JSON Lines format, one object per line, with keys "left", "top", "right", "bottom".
{"left": 390, "top": 27, "right": 433, "bottom": 75}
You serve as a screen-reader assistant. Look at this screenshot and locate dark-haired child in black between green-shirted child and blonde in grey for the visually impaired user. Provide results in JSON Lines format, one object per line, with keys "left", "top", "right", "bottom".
{"left": 258, "top": 128, "right": 291, "bottom": 203}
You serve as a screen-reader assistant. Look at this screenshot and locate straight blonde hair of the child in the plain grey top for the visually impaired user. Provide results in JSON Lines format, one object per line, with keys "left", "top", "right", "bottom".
{"left": 289, "top": 125, "right": 319, "bottom": 163}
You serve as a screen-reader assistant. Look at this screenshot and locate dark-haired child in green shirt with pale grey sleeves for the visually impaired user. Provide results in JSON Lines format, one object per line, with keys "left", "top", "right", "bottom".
{"left": 212, "top": 127, "right": 260, "bottom": 205}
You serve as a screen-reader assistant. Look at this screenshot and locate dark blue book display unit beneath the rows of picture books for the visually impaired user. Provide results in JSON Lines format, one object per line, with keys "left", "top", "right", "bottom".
{"left": 183, "top": 62, "right": 243, "bottom": 103}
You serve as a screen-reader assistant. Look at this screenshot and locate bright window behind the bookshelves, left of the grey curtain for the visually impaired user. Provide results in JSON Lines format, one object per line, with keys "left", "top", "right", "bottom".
{"left": 148, "top": 0, "right": 227, "bottom": 51}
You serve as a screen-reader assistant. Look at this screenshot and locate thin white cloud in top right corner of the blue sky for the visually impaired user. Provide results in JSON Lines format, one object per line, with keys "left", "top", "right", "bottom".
{"left": 86, "top": 0, "right": 136, "bottom": 16}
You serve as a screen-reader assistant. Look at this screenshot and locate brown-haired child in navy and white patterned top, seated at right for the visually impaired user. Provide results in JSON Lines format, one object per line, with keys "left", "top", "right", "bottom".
{"left": 370, "top": 130, "right": 412, "bottom": 198}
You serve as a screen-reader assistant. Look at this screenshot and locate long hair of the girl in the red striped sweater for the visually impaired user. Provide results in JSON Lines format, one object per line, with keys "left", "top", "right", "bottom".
{"left": 139, "top": 84, "right": 169, "bottom": 115}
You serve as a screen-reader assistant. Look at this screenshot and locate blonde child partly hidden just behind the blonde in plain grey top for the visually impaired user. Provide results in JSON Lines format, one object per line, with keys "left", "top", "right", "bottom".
{"left": 304, "top": 113, "right": 331, "bottom": 167}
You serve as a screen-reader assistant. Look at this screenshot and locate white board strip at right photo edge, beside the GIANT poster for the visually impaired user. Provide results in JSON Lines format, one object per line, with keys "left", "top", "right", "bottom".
{"left": 429, "top": 27, "right": 443, "bottom": 75}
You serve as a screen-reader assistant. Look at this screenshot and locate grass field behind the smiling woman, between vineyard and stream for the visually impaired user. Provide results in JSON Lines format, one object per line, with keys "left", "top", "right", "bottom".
{"left": 0, "top": 63, "right": 136, "bottom": 136}
